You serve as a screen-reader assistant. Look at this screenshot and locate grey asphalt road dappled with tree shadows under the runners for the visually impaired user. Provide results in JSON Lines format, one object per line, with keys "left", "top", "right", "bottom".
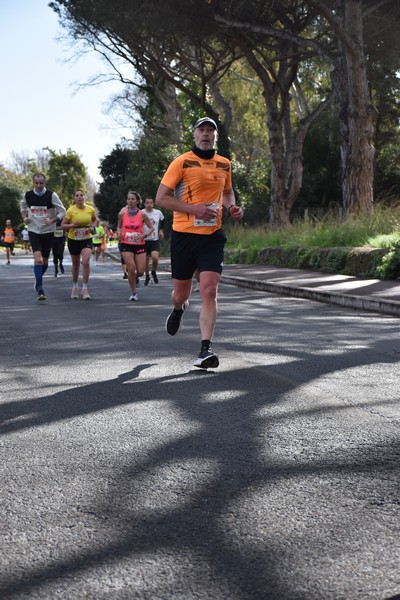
{"left": 0, "top": 255, "right": 400, "bottom": 600}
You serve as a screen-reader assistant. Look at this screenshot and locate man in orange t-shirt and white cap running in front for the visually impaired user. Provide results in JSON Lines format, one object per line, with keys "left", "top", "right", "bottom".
{"left": 156, "top": 117, "right": 243, "bottom": 369}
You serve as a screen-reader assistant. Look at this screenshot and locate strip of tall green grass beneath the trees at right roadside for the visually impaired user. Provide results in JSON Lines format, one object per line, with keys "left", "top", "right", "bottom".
{"left": 227, "top": 204, "right": 400, "bottom": 254}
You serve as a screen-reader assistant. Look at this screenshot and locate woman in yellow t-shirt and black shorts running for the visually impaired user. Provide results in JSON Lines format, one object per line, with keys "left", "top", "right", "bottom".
{"left": 61, "top": 190, "right": 96, "bottom": 300}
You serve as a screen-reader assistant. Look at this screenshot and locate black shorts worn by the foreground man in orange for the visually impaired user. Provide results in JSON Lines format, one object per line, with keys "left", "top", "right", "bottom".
{"left": 171, "top": 229, "right": 226, "bottom": 280}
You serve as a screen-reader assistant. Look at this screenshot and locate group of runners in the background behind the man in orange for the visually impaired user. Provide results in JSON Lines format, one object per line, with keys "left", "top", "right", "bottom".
{"left": 15, "top": 173, "right": 164, "bottom": 302}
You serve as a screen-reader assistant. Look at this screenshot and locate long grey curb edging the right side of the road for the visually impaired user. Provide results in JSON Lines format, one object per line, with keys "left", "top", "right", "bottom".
{"left": 221, "top": 275, "right": 400, "bottom": 317}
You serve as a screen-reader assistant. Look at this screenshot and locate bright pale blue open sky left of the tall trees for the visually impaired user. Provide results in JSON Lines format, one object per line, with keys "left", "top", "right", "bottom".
{"left": 0, "top": 0, "right": 130, "bottom": 182}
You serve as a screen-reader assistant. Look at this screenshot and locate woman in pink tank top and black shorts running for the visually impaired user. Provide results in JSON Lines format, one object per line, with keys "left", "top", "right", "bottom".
{"left": 118, "top": 192, "right": 154, "bottom": 302}
